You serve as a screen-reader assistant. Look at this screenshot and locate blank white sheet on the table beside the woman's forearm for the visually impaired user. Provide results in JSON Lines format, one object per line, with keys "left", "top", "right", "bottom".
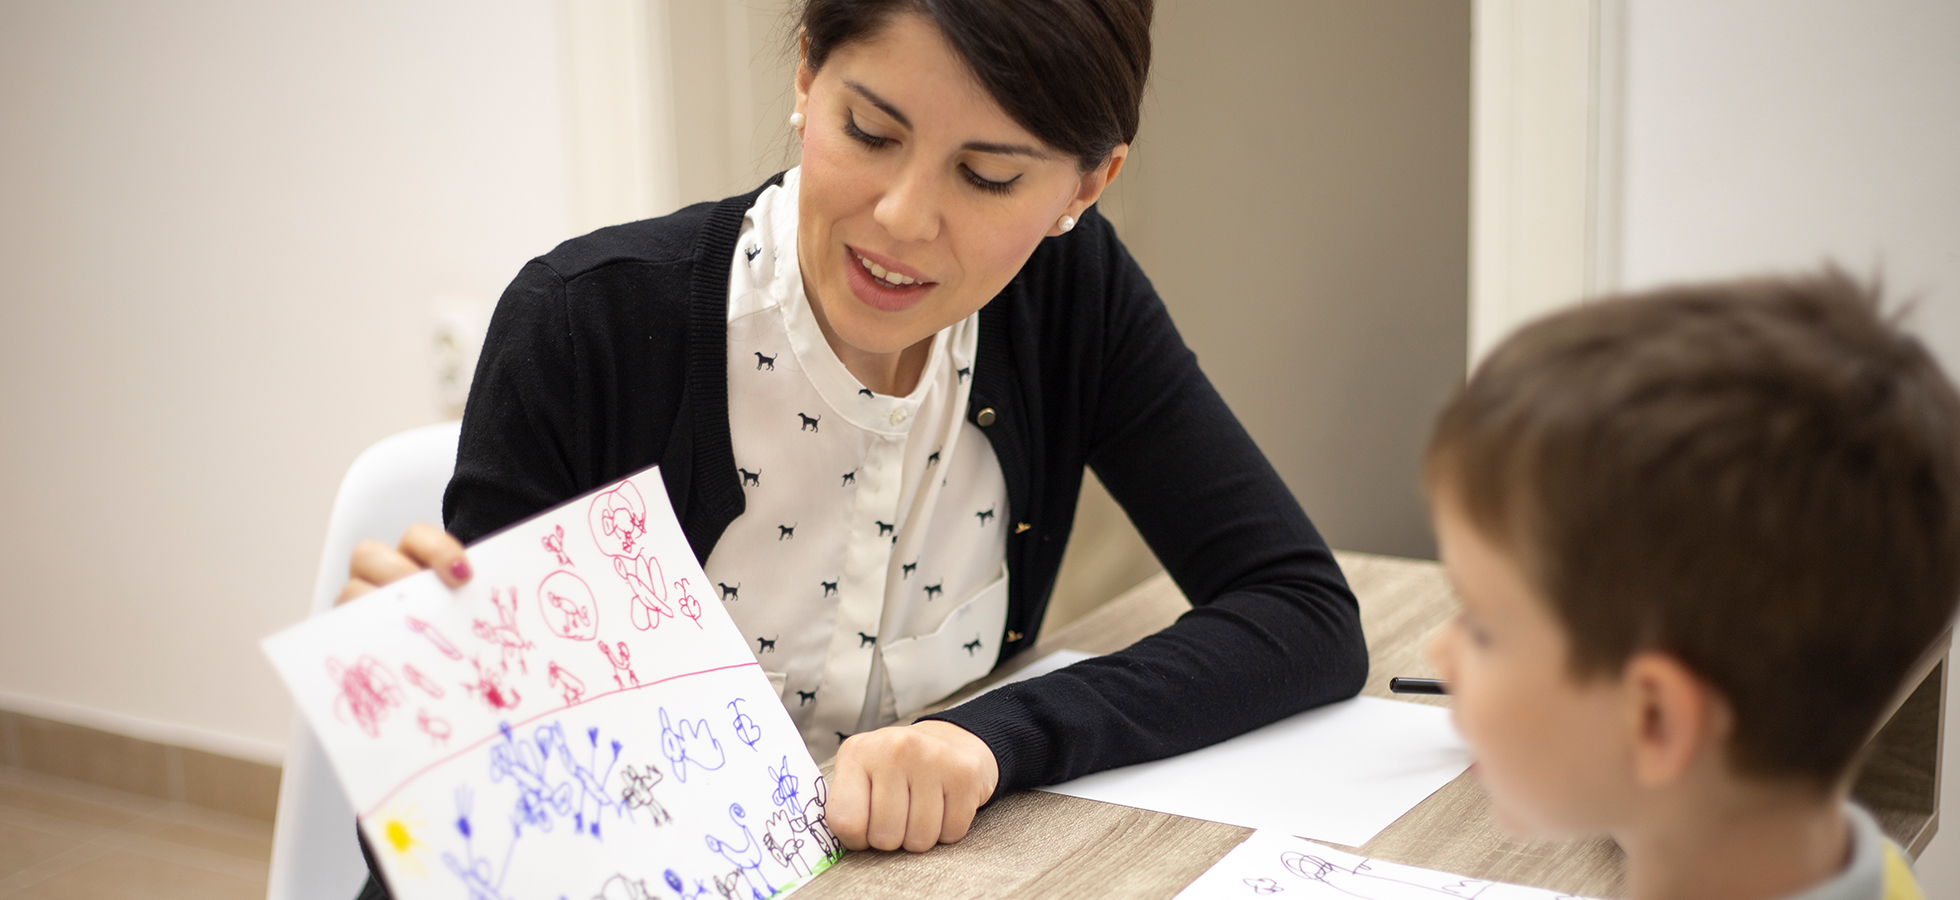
{"left": 1041, "top": 696, "right": 1470, "bottom": 847}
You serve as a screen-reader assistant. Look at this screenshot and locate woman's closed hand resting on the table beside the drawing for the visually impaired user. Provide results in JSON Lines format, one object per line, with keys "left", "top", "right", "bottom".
{"left": 823, "top": 722, "right": 1000, "bottom": 853}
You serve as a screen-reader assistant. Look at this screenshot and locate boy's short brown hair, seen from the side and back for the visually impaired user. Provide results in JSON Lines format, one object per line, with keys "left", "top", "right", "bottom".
{"left": 1425, "top": 267, "right": 1960, "bottom": 786}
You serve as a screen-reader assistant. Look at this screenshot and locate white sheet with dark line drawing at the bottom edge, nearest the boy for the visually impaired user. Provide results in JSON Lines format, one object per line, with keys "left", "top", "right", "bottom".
{"left": 1178, "top": 829, "right": 1582, "bottom": 900}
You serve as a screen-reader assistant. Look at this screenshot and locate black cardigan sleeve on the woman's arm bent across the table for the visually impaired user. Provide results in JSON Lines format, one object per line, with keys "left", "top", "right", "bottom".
{"left": 929, "top": 218, "right": 1368, "bottom": 796}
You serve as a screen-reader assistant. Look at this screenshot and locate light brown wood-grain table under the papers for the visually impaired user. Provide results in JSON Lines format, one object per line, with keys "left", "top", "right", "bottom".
{"left": 798, "top": 553, "right": 1952, "bottom": 900}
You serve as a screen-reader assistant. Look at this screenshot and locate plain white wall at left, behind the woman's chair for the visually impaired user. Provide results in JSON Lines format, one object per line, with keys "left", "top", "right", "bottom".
{"left": 0, "top": 0, "right": 566, "bottom": 761}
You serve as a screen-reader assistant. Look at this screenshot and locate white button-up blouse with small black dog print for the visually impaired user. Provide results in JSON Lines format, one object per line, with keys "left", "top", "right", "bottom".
{"left": 706, "top": 169, "right": 1007, "bottom": 759}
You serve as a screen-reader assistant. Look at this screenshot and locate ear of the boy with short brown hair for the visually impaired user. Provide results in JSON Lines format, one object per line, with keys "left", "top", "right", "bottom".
{"left": 1621, "top": 651, "right": 1731, "bottom": 788}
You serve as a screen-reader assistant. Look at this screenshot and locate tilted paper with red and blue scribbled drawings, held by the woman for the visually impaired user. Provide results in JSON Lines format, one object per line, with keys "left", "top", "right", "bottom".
{"left": 265, "top": 469, "right": 839, "bottom": 900}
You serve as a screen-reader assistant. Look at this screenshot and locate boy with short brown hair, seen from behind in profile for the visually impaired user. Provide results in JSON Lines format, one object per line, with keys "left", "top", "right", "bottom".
{"left": 1425, "top": 269, "right": 1960, "bottom": 900}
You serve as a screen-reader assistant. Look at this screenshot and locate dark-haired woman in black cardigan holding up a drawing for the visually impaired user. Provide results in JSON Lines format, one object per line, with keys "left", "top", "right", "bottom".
{"left": 349, "top": 0, "right": 1366, "bottom": 886}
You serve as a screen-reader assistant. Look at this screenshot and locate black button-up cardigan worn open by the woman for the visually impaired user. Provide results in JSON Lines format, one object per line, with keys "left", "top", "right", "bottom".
{"left": 443, "top": 176, "right": 1368, "bottom": 796}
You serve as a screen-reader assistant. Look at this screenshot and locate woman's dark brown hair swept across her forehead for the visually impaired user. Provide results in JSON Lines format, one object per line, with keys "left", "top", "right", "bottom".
{"left": 802, "top": 0, "right": 1154, "bottom": 171}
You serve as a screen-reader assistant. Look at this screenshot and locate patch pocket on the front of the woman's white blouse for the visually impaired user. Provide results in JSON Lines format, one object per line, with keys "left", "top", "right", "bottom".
{"left": 884, "top": 567, "right": 1007, "bottom": 718}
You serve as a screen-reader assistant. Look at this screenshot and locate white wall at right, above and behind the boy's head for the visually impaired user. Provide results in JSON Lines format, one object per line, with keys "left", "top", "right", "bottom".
{"left": 1621, "top": 0, "right": 1960, "bottom": 896}
